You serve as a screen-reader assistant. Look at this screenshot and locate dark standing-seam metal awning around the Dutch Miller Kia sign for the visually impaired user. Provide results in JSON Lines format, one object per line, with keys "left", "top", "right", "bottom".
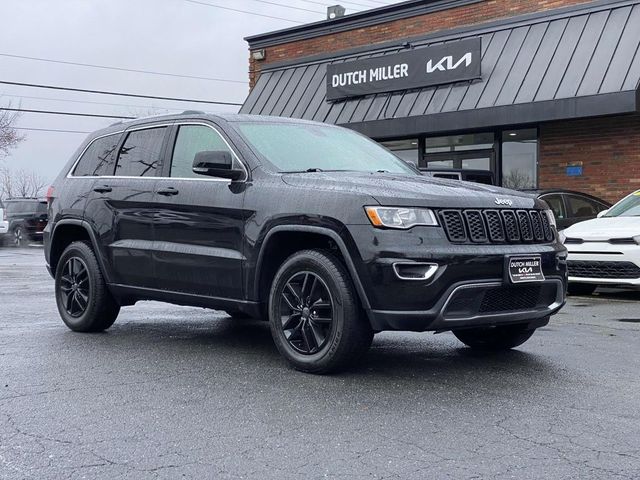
{"left": 241, "top": 0, "right": 640, "bottom": 138}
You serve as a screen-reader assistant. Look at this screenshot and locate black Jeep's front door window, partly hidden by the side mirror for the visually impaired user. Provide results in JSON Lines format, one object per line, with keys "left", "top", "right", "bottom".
{"left": 171, "top": 125, "right": 235, "bottom": 178}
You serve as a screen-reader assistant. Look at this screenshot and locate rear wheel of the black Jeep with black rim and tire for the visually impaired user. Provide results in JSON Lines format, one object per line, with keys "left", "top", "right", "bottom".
{"left": 55, "top": 242, "right": 120, "bottom": 332}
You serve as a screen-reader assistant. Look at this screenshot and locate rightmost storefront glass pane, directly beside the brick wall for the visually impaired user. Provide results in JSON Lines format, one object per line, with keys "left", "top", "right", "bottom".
{"left": 502, "top": 128, "right": 538, "bottom": 190}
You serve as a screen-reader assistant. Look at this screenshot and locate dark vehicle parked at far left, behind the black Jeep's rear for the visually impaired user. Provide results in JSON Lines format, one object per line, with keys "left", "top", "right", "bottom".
{"left": 4, "top": 198, "right": 48, "bottom": 246}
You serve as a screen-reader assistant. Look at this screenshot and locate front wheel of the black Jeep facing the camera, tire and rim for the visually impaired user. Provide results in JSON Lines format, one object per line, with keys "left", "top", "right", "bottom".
{"left": 269, "top": 250, "right": 373, "bottom": 374}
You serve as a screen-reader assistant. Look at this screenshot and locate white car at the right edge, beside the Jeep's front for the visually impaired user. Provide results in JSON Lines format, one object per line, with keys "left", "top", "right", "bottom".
{"left": 561, "top": 190, "right": 640, "bottom": 295}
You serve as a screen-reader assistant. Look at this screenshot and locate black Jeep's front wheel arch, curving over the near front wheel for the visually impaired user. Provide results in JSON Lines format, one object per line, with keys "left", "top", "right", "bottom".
{"left": 252, "top": 225, "right": 371, "bottom": 311}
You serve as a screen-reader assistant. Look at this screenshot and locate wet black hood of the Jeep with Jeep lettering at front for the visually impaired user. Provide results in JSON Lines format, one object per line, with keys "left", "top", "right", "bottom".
{"left": 282, "top": 172, "right": 547, "bottom": 208}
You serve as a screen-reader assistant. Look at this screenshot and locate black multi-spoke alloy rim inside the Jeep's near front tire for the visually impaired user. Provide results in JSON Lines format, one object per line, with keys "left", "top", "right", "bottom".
{"left": 280, "top": 271, "right": 334, "bottom": 355}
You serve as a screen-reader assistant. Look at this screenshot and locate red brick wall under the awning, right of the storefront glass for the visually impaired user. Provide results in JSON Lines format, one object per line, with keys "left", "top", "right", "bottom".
{"left": 539, "top": 115, "right": 640, "bottom": 203}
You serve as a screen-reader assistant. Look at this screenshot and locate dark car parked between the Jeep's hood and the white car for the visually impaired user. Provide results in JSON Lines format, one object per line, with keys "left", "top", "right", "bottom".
{"left": 526, "top": 189, "right": 611, "bottom": 230}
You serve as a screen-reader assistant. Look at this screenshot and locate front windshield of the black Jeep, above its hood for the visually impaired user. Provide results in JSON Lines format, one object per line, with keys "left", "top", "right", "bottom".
{"left": 237, "top": 122, "right": 419, "bottom": 175}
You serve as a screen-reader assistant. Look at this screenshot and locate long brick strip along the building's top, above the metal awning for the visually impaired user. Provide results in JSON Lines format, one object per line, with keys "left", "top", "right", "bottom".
{"left": 249, "top": 0, "right": 588, "bottom": 87}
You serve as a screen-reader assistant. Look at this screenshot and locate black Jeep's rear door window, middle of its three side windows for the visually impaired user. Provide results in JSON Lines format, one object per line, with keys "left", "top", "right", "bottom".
{"left": 116, "top": 127, "right": 167, "bottom": 177}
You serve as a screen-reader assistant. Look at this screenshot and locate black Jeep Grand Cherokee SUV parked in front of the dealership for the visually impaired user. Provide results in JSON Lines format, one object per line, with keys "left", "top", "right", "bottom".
{"left": 45, "top": 112, "right": 566, "bottom": 373}
